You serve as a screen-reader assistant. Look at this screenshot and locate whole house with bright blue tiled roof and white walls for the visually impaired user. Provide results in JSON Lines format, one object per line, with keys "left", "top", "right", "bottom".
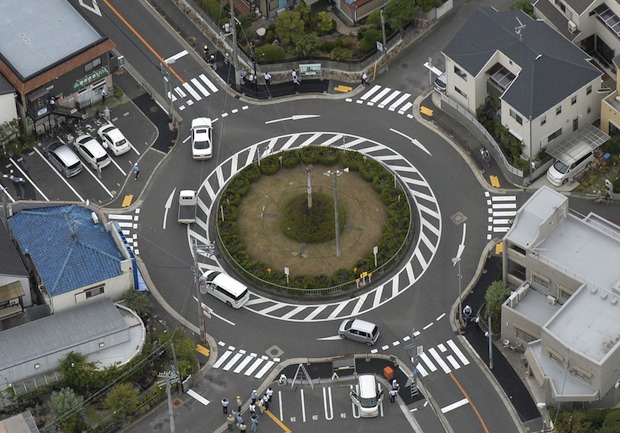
{"left": 8, "top": 205, "right": 135, "bottom": 314}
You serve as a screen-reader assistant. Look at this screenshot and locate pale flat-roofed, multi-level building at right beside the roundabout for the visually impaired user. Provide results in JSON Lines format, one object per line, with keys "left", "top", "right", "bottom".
{"left": 501, "top": 187, "right": 620, "bottom": 407}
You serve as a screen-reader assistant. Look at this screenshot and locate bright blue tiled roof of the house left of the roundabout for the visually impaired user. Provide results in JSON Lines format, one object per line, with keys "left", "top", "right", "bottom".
{"left": 9, "top": 205, "right": 123, "bottom": 296}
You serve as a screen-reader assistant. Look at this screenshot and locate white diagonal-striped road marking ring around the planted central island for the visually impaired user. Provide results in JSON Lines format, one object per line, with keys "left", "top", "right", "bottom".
{"left": 188, "top": 132, "right": 442, "bottom": 322}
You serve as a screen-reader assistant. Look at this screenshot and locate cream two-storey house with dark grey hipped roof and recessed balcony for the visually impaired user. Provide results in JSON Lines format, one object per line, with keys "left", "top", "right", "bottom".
{"left": 443, "top": 7, "right": 604, "bottom": 165}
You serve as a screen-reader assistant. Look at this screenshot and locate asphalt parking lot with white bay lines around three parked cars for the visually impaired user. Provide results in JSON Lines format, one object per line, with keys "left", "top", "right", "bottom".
{"left": 0, "top": 100, "right": 163, "bottom": 204}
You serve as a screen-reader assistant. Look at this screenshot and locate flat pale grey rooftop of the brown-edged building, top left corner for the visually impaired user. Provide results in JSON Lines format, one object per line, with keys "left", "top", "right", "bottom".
{"left": 0, "top": 0, "right": 104, "bottom": 82}
